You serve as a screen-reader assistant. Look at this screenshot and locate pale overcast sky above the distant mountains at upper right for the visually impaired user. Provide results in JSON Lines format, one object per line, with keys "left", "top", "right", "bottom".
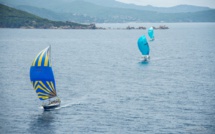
{"left": 116, "top": 0, "right": 215, "bottom": 8}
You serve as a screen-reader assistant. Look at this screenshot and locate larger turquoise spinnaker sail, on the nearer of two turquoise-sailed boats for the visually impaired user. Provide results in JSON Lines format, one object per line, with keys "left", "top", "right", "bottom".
{"left": 137, "top": 35, "right": 150, "bottom": 55}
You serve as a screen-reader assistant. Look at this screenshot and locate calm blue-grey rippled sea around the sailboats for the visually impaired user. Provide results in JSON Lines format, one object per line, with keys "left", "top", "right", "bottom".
{"left": 0, "top": 23, "right": 215, "bottom": 134}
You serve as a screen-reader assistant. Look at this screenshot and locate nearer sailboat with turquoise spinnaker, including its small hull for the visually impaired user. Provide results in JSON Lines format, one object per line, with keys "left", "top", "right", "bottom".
{"left": 137, "top": 35, "right": 150, "bottom": 62}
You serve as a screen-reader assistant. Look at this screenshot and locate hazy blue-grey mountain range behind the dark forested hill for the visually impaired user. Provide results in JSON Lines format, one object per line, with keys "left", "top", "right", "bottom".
{"left": 0, "top": 0, "right": 215, "bottom": 23}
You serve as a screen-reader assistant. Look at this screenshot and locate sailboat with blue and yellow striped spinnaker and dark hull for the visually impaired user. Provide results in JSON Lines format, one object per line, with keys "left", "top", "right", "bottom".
{"left": 30, "top": 46, "right": 61, "bottom": 110}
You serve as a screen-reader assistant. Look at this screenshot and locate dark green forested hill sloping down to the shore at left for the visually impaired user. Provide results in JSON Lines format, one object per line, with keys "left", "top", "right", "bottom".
{"left": 0, "top": 4, "right": 96, "bottom": 29}
